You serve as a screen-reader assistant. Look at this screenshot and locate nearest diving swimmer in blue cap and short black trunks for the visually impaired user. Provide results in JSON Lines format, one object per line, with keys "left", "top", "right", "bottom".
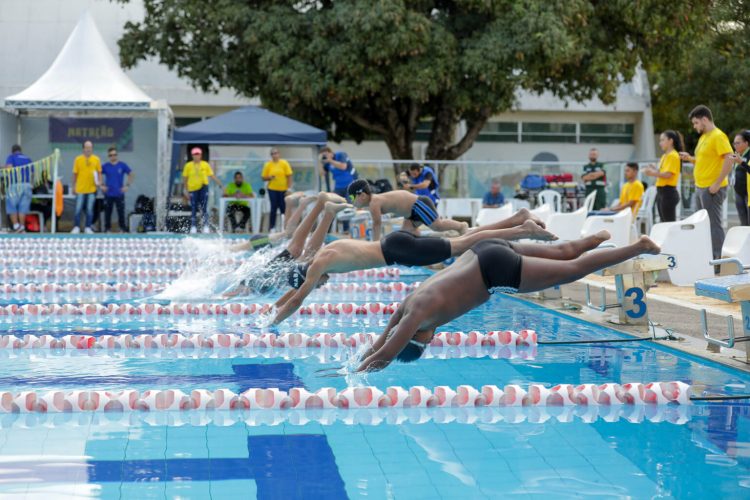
{"left": 357, "top": 231, "right": 660, "bottom": 371}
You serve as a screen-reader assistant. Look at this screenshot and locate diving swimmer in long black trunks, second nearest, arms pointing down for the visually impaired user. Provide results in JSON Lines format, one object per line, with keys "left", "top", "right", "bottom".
{"left": 273, "top": 209, "right": 560, "bottom": 324}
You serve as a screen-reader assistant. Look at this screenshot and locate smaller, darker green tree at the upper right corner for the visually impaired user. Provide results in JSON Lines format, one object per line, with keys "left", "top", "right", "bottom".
{"left": 649, "top": 0, "right": 750, "bottom": 149}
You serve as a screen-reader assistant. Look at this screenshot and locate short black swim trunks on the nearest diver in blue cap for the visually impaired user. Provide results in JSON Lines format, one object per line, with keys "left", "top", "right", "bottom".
{"left": 471, "top": 239, "right": 522, "bottom": 295}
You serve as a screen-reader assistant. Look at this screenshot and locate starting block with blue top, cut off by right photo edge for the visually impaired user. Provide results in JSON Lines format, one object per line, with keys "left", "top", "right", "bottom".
{"left": 695, "top": 258, "right": 750, "bottom": 362}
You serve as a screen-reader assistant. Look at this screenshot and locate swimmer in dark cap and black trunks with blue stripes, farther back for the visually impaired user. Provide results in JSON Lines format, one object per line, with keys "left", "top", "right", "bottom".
{"left": 347, "top": 179, "right": 469, "bottom": 240}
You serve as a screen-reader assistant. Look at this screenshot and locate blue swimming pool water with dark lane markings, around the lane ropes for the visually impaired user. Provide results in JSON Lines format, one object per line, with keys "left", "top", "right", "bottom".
{"left": 0, "top": 238, "right": 750, "bottom": 499}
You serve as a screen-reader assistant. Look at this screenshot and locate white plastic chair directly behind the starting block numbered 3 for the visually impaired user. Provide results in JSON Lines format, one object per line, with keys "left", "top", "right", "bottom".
{"left": 650, "top": 210, "right": 714, "bottom": 286}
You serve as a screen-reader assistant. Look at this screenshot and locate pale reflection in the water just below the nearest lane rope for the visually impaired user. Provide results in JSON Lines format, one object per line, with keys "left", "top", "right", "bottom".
{"left": 0, "top": 405, "right": 693, "bottom": 429}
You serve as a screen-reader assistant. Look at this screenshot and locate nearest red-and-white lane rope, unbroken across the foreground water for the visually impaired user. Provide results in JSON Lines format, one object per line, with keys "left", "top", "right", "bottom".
{"left": 0, "top": 382, "right": 690, "bottom": 413}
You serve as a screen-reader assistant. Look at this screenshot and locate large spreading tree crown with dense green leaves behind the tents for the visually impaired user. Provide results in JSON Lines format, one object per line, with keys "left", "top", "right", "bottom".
{"left": 119, "top": 0, "right": 710, "bottom": 160}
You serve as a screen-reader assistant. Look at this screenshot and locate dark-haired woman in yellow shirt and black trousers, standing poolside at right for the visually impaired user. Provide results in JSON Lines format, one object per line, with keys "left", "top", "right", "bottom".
{"left": 643, "top": 130, "right": 683, "bottom": 222}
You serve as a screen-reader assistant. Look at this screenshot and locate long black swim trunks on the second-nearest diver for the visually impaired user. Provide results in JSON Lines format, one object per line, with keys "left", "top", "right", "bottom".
{"left": 380, "top": 231, "right": 451, "bottom": 266}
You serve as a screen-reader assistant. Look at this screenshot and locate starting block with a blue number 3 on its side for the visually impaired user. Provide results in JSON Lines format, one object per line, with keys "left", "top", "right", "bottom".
{"left": 586, "top": 254, "right": 672, "bottom": 327}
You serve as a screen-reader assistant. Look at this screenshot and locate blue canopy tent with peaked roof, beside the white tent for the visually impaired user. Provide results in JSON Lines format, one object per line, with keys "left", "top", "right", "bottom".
{"left": 171, "top": 106, "right": 327, "bottom": 230}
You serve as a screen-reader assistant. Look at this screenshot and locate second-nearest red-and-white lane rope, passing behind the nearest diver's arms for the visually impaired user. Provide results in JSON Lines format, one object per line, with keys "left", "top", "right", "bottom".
{"left": 0, "top": 330, "right": 537, "bottom": 357}
